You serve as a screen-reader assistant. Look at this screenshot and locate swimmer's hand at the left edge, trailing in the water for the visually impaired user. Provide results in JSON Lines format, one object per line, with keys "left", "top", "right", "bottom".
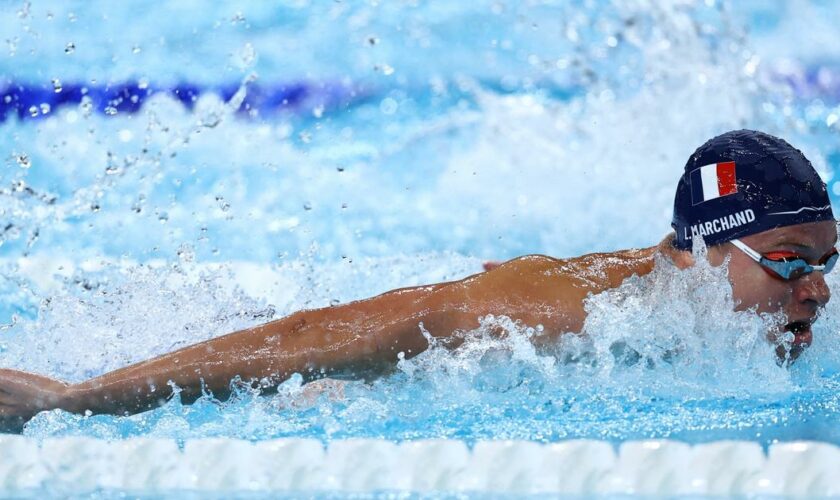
{"left": 0, "top": 369, "right": 70, "bottom": 432}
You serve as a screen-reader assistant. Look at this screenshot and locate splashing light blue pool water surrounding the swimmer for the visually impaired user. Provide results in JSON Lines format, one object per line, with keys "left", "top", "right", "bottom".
{"left": 0, "top": 1, "right": 840, "bottom": 450}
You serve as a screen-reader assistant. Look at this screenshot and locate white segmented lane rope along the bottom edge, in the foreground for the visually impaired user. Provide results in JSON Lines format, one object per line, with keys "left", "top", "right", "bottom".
{"left": 0, "top": 435, "right": 840, "bottom": 496}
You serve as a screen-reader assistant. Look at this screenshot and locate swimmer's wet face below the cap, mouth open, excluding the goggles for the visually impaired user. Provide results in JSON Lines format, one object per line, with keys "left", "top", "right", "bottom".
{"left": 709, "top": 221, "right": 837, "bottom": 359}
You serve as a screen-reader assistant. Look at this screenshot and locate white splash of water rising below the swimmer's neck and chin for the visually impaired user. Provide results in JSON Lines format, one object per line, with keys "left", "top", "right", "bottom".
{"left": 576, "top": 250, "right": 790, "bottom": 393}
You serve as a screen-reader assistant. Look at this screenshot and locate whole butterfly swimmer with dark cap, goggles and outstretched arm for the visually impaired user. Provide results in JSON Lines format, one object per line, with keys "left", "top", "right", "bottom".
{"left": 0, "top": 130, "right": 837, "bottom": 430}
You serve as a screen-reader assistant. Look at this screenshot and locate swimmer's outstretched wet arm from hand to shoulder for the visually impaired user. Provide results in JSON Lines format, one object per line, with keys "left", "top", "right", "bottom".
{"left": 0, "top": 254, "right": 583, "bottom": 420}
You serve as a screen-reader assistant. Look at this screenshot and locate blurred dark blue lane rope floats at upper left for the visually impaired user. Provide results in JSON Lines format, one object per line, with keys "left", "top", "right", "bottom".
{"left": 0, "top": 80, "right": 370, "bottom": 122}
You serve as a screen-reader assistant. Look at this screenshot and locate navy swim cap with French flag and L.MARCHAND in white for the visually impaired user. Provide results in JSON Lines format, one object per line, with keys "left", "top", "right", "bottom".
{"left": 671, "top": 130, "right": 834, "bottom": 250}
